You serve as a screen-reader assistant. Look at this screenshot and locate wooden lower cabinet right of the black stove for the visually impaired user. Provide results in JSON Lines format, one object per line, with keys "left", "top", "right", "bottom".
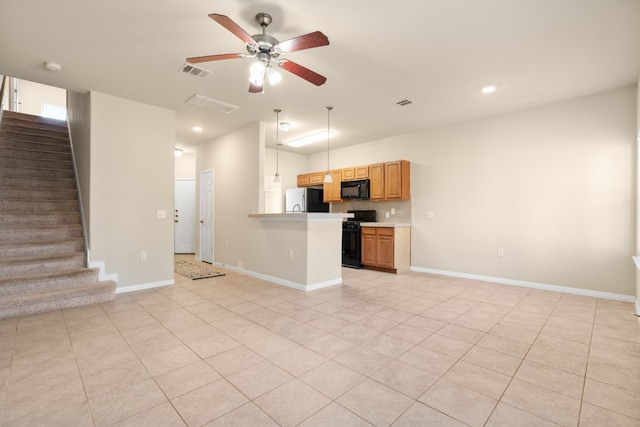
{"left": 361, "top": 225, "right": 411, "bottom": 273}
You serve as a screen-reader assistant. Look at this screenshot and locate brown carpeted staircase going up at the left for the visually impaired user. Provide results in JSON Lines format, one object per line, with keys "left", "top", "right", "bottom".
{"left": 0, "top": 111, "right": 117, "bottom": 319}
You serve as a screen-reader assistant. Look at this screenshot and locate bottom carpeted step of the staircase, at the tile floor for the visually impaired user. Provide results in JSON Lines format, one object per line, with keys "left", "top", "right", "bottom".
{"left": 0, "top": 280, "right": 118, "bottom": 319}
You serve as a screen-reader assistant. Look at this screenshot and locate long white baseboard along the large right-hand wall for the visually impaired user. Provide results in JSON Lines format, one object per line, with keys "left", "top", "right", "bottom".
{"left": 411, "top": 266, "right": 639, "bottom": 304}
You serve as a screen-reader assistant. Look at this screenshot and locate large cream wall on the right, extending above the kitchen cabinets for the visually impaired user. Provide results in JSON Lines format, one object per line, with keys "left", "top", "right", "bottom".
{"left": 307, "top": 86, "right": 637, "bottom": 295}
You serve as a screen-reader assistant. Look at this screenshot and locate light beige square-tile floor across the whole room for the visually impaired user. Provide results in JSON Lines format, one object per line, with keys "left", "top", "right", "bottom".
{"left": 0, "top": 258, "right": 640, "bottom": 426}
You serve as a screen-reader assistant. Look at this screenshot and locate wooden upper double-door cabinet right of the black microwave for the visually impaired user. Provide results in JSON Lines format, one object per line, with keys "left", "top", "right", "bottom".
{"left": 369, "top": 160, "right": 411, "bottom": 200}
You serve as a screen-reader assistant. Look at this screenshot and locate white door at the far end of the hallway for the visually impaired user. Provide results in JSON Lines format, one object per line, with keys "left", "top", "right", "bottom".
{"left": 173, "top": 179, "right": 196, "bottom": 254}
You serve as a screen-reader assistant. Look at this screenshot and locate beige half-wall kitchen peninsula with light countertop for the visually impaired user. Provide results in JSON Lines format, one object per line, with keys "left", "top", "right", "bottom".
{"left": 245, "top": 213, "right": 353, "bottom": 291}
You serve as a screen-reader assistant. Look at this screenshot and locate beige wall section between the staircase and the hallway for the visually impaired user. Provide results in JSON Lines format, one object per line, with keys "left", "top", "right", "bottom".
{"left": 89, "top": 92, "right": 175, "bottom": 288}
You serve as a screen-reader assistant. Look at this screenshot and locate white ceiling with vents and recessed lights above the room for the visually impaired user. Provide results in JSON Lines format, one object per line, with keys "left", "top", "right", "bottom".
{"left": 0, "top": 0, "right": 640, "bottom": 154}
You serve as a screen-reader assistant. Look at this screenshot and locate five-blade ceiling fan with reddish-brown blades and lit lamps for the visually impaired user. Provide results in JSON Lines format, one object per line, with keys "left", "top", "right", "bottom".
{"left": 187, "top": 13, "right": 329, "bottom": 93}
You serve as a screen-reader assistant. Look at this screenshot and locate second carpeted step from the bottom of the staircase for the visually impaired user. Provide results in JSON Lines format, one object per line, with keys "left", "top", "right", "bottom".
{"left": 0, "top": 268, "right": 99, "bottom": 296}
